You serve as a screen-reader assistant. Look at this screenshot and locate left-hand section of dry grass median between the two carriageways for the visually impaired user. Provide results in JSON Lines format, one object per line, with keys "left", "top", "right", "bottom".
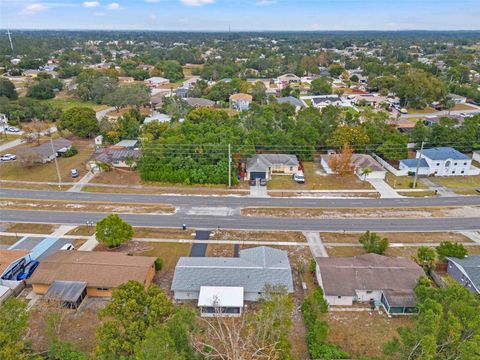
{"left": 0, "top": 198, "right": 175, "bottom": 214}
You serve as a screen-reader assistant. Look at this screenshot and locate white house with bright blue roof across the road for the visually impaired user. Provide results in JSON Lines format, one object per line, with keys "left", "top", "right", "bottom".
{"left": 400, "top": 147, "right": 480, "bottom": 176}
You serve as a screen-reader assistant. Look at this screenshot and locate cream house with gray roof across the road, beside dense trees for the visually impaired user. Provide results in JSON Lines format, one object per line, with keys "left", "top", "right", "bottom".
{"left": 246, "top": 154, "right": 300, "bottom": 180}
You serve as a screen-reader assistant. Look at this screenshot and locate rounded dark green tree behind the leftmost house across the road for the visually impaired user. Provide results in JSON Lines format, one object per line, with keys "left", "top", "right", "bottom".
{"left": 59, "top": 107, "right": 100, "bottom": 138}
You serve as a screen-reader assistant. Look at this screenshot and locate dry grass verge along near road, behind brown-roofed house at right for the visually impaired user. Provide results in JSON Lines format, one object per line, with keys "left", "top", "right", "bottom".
{"left": 321, "top": 232, "right": 472, "bottom": 244}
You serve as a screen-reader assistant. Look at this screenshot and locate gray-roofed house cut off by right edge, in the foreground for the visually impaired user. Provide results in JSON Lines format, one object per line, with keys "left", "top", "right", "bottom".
{"left": 447, "top": 255, "right": 480, "bottom": 294}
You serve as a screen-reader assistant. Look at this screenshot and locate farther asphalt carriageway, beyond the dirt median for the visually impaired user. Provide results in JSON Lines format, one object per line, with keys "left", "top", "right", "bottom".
{"left": 0, "top": 189, "right": 480, "bottom": 208}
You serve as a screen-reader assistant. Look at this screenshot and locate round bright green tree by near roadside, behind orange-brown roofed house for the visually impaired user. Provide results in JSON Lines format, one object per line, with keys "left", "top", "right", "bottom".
{"left": 95, "top": 214, "right": 133, "bottom": 248}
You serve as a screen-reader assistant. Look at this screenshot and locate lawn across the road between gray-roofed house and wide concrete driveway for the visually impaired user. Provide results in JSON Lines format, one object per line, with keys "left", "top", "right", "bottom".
{"left": 268, "top": 162, "right": 372, "bottom": 190}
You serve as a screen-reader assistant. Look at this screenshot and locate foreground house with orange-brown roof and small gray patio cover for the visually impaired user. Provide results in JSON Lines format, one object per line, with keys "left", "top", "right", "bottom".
{"left": 28, "top": 251, "right": 156, "bottom": 303}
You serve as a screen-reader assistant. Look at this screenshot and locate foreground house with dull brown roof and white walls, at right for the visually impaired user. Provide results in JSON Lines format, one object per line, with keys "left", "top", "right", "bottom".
{"left": 316, "top": 254, "right": 424, "bottom": 315}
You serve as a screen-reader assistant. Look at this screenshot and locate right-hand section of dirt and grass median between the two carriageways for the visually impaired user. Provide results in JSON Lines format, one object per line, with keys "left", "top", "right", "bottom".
{"left": 242, "top": 206, "right": 480, "bottom": 219}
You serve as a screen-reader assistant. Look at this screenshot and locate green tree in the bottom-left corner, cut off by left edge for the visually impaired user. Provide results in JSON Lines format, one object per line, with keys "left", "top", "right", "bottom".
{"left": 0, "top": 298, "right": 28, "bottom": 360}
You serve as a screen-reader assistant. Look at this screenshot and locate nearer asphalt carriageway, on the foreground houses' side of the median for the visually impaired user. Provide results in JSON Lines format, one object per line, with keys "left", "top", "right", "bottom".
{"left": 0, "top": 210, "right": 480, "bottom": 232}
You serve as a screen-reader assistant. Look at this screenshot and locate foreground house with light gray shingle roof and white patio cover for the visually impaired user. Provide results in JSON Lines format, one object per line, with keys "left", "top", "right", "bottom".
{"left": 171, "top": 246, "right": 293, "bottom": 307}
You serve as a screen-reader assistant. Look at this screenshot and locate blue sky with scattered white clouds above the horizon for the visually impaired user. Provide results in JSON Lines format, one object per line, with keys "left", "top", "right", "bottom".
{"left": 0, "top": 0, "right": 480, "bottom": 31}
